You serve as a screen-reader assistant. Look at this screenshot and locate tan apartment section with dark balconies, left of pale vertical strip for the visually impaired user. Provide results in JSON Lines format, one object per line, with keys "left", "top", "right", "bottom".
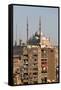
{"left": 23, "top": 45, "right": 38, "bottom": 84}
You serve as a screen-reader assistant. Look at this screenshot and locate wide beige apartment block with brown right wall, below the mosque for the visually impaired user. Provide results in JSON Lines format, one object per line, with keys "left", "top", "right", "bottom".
{"left": 13, "top": 42, "right": 56, "bottom": 84}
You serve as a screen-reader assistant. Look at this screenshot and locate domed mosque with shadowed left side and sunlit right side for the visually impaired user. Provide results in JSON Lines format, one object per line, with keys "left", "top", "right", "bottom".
{"left": 28, "top": 32, "right": 52, "bottom": 47}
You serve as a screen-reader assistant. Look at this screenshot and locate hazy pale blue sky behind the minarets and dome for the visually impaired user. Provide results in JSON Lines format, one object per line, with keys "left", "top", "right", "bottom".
{"left": 13, "top": 6, "right": 58, "bottom": 44}
